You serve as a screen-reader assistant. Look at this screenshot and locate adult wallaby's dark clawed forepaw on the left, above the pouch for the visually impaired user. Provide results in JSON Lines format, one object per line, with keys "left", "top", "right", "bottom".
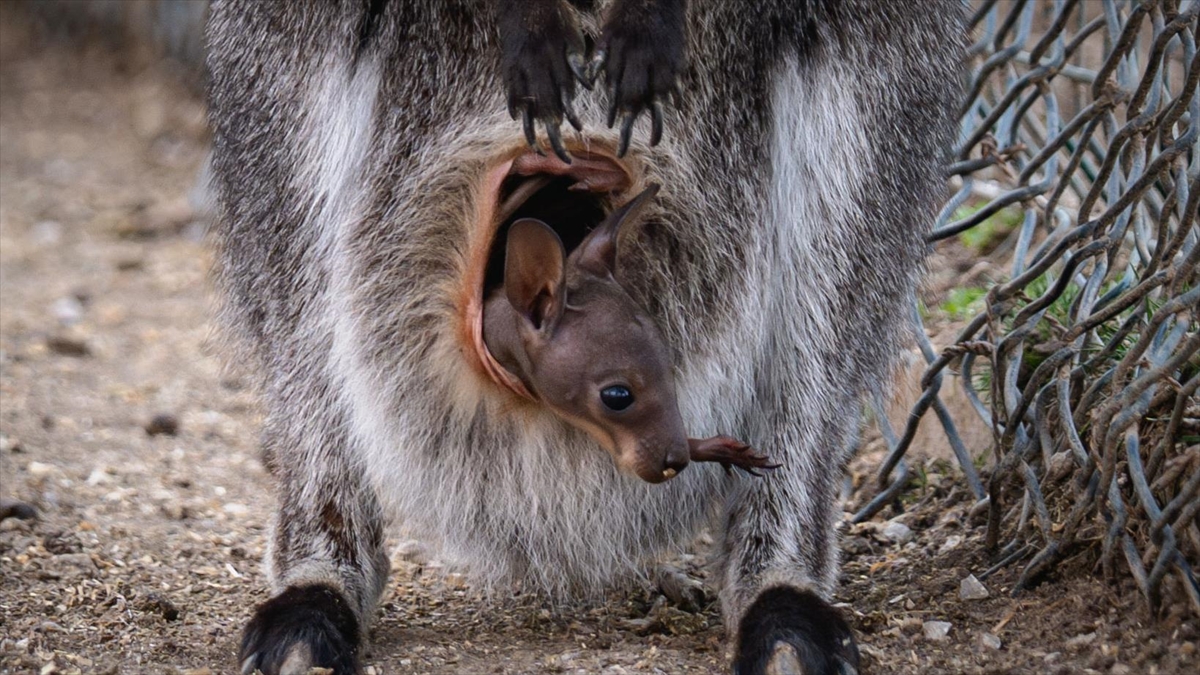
{"left": 499, "top": 2, "right": 587, "bottom": 163}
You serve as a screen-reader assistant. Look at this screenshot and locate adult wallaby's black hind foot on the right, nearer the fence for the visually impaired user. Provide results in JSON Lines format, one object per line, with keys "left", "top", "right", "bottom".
{"left": 733, "top": 586, "right": 858, "bottom": 675}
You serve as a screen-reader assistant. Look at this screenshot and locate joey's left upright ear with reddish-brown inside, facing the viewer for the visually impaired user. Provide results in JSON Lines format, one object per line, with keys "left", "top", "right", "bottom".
{"left": 504, "top": 217, "right": 566, "bottom": 330}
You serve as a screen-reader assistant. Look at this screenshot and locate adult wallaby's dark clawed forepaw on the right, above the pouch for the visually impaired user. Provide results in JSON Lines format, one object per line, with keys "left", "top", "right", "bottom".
{"left": 589, "top": 0, "right": 686, "bottom": 156}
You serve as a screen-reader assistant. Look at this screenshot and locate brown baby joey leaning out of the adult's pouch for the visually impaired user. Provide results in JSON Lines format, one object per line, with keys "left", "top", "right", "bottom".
{"left": 484, "top": 185, "right": 779, "bottom": 483}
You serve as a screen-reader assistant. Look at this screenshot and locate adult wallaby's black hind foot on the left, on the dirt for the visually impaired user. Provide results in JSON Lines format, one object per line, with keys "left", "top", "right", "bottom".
{"left": 238, "top": 585, "right": 359, "bottom": 675}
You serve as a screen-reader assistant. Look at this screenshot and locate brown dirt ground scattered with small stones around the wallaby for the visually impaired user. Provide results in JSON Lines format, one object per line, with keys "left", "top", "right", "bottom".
{"left": 0, "top": 13, "right": 1200, "bottom": 675}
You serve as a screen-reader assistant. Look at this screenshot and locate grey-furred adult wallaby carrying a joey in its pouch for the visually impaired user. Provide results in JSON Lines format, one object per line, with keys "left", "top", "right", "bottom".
{"left": 201, "top": 0, "right": 960, "bottom": 674}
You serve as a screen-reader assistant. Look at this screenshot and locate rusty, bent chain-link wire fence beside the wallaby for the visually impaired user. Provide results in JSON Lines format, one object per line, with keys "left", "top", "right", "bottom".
{"left": 853, "top": 0, "right": 1200, "bottom": 611}
